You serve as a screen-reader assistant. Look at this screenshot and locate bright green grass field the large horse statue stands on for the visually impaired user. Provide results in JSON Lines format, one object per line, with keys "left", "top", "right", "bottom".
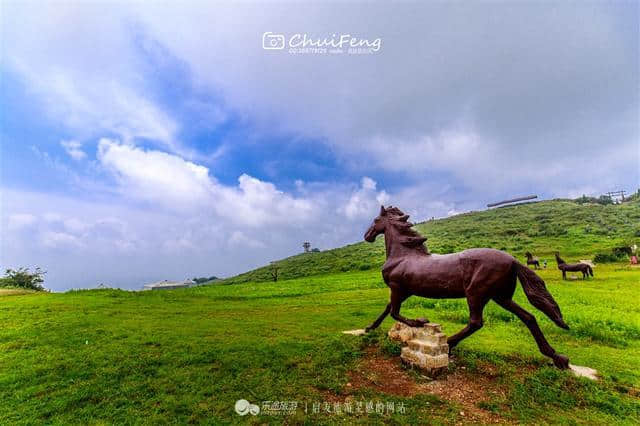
{"left": 0, "top": 199, "right": 640, "bottom": 424}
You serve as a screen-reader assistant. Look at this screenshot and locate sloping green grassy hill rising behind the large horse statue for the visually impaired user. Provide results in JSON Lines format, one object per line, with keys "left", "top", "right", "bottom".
{"left": 225, "top": 200, "right": 640, "bottom": 284}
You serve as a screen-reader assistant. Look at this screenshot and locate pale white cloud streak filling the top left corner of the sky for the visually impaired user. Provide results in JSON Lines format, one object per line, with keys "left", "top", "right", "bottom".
{"left": 2, "top": 1, "right": 180, "bottom": 155}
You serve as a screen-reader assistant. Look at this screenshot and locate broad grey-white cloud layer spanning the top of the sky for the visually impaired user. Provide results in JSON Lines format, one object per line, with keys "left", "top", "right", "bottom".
{"left": 3, "top": 2, "right": 639, "bottom": 188}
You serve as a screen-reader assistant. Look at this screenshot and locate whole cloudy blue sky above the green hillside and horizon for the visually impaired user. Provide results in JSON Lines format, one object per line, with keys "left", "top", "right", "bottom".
{"left": 0, "top": 2, "right": 640, "bottom": 290}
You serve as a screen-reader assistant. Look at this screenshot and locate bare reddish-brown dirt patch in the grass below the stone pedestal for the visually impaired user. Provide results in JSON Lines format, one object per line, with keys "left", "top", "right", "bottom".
{"left": 346, "top": 348, "right": 512, "bottom": 423}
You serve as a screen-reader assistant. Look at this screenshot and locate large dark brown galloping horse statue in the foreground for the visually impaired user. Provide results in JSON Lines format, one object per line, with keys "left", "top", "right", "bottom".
{"left": 364, "top": 206, "right": 569, "bottom": 369}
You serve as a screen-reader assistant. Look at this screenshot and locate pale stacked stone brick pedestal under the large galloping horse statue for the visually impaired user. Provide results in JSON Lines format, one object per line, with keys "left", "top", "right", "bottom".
{"left": 388, "top": 322, "right": 449, "bottom": 377}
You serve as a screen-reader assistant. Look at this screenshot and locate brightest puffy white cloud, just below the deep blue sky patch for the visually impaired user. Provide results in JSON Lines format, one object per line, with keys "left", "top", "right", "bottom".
{"left": 98, "top": 139, "right": 314, "bottom": 226}
